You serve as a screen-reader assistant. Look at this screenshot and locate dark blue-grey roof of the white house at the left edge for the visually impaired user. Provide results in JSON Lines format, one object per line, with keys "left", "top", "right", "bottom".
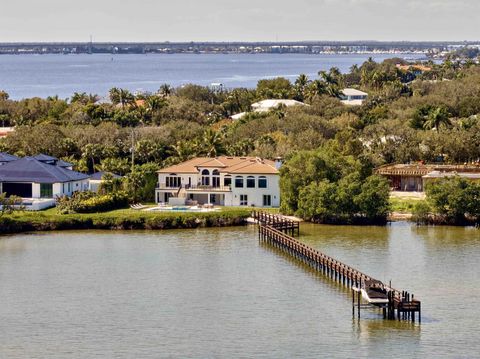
{"left": 0, "top": 157, "right": 90, "bottom": 183}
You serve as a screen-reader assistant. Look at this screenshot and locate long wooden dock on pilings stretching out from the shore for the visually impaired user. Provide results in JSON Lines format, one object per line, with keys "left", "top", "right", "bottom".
{"left": 252, "top": 211, "right": 421, "bottom": 322}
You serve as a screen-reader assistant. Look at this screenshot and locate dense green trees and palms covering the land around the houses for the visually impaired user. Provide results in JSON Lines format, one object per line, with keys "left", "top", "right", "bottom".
{"left": 0, "top": 58, "right": 480, "bottom": 225}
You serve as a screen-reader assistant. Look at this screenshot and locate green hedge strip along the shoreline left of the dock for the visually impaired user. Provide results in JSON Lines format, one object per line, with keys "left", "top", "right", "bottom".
{"left": 0, "top": 208, "right": 252, "bottom": 234}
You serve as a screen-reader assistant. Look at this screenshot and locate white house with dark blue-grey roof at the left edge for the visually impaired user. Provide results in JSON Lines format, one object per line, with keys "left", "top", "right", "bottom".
{"left": 0, "top": 156, "right": 89, "bottom": 209}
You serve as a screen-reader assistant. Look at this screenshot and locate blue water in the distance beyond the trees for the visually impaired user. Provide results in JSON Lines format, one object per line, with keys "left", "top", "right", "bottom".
{"left": 0, "top": 54, "right": 423, "bottom": 99}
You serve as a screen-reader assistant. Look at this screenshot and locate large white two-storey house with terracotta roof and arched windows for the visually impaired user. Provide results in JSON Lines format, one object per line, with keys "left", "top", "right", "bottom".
{"left": 155, "top": 156, "right": 281, "bottom": 207}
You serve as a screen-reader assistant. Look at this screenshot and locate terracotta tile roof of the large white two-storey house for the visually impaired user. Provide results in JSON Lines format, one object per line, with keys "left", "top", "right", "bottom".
{"left": 158, "top": 156, "right": 278, "bottom": 174}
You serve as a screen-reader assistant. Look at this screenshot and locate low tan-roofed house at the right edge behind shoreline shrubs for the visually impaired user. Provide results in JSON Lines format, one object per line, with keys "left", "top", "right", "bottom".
{"left": 375, "top": 163, "right": 480, "bottom": 192}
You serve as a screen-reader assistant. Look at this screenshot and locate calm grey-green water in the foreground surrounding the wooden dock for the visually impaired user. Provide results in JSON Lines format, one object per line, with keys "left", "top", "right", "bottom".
{"left": 0, "top": 224, "right": 480, "bottom": 359}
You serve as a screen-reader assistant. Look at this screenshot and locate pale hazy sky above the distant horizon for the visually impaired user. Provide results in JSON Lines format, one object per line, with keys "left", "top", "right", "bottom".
{"left": 0, "top": 0, "right": 480, "bottom": 42}
